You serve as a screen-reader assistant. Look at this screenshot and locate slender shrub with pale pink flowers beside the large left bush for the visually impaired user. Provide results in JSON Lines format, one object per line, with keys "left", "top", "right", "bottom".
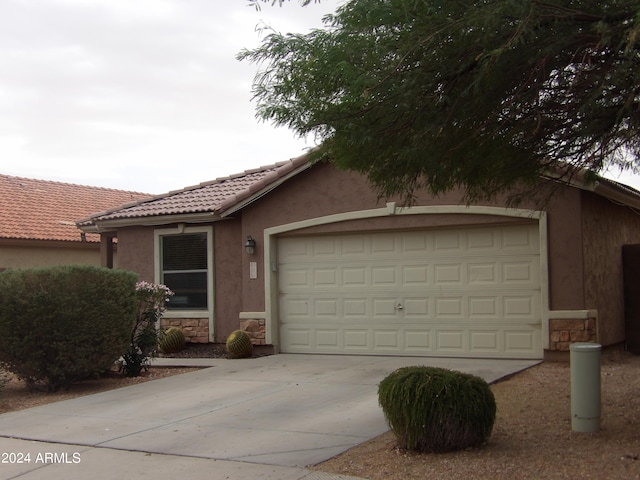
{"left": 120, "top": 281, "right": 173, "bottom": 377}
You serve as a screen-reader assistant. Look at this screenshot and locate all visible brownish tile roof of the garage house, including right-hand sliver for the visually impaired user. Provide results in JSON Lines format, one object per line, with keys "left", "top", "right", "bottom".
{"left": 78, "top": 151, "right": 640, "bottom": 232}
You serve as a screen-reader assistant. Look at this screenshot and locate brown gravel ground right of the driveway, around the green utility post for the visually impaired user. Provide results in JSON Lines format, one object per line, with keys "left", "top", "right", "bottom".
{"left": 315, "top": 351, "right": 640, "bottom": 480}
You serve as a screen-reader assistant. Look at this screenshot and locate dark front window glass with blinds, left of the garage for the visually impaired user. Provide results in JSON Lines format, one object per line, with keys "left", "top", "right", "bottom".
{"left": 160, "top": 233, "right": 208, "bottom": 310}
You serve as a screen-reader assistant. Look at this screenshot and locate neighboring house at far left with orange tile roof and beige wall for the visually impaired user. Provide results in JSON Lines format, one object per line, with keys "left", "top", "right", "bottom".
{"left": 0, "top": 174, "right": 150, "bottom": 270}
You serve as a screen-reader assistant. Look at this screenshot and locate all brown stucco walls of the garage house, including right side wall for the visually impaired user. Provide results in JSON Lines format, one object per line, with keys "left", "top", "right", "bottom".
{"left": 107, "top": 164, "right": 640, "bottom": 345}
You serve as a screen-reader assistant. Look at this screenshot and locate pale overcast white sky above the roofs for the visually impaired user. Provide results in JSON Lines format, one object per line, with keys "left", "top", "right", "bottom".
{"left": 0, "top": 0, "right": 640, "bottom": 193}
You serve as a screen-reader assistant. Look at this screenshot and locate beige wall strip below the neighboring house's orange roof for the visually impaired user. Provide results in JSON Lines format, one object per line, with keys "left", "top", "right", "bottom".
{"left": 0, "top": 242, "right": 100, "bottom": 270}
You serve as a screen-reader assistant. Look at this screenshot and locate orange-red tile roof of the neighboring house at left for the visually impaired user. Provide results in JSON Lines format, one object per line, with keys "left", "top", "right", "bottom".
{"left": 0, "top": 174, "right": 150, "bottom": 242}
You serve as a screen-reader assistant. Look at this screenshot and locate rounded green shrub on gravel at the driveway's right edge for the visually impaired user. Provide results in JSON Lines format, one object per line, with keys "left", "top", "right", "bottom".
{"left": 378, "top": 367, "right": 496, "bottom": 452}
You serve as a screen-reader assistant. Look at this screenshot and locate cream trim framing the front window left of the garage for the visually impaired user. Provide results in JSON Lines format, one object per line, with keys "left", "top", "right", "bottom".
{"left": 153, "top": 224, "right": 215, "bottom": 342}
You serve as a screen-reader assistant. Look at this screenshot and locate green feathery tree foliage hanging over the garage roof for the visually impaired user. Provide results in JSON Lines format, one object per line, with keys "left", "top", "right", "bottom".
{"left": 238, "top": 0, "right": 640, "bottom": 201}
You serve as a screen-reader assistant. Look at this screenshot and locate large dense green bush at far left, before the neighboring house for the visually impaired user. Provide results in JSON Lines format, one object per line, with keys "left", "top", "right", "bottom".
{"left": 0, "top": 265, "right": 137, "bottom": 391}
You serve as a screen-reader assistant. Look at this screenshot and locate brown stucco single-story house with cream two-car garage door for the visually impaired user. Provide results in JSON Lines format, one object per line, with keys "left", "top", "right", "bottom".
{"left": 78, "top": 156, "right": 640, "bottom": 359}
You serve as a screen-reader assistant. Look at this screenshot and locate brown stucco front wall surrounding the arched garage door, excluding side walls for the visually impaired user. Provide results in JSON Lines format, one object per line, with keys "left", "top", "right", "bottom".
{"left": 236, "top": 165, "right": 585, "bottom": 311}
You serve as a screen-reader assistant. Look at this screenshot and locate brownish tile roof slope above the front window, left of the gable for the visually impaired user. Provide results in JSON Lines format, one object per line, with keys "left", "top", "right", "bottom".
{"left": 78, "top": 155, "right": 309, "bottom": 227}
